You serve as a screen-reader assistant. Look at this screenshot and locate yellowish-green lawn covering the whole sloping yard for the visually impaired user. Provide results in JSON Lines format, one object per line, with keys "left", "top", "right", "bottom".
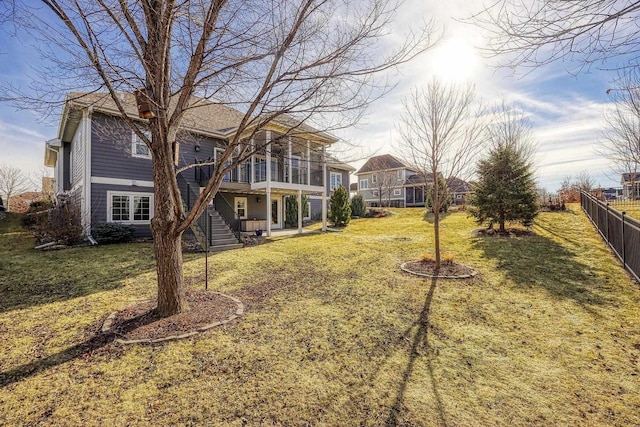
{"left": 0, "top": 209, "right": 640, "bottom": 426}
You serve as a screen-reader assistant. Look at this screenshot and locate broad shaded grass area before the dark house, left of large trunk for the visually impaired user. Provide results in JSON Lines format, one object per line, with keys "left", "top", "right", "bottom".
{"left": 0, "top": 243, "right": 155, "bottom": 314}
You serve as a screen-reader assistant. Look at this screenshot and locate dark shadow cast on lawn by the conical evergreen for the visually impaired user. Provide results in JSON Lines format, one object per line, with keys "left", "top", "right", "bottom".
{"left": 472, "top": 235, "right": 608, "bottom": 305}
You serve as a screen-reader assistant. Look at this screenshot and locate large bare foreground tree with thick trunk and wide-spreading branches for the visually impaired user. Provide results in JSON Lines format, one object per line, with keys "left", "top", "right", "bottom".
{"left": 0, "top": 0, "right": 432, "bottom": 316}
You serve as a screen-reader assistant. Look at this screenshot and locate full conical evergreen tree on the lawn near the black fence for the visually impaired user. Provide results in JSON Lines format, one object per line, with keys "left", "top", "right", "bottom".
{"left": 469, "top": 144, "right": 538, "bottom": 231}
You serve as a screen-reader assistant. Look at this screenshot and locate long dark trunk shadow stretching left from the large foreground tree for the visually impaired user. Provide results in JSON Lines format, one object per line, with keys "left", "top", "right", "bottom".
{"left": 0, "top": 314, "right": 155, "bottom": 387}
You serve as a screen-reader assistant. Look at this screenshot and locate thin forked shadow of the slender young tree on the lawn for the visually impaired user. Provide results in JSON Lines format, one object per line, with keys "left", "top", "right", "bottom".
{"left": 386, "top": 277, "right": 447, "bottom": 426}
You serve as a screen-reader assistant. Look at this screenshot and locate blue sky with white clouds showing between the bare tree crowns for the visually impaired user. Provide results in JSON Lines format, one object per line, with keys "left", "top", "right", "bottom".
{"left": 0, "top": 0, "right": 619, "bottom": 191}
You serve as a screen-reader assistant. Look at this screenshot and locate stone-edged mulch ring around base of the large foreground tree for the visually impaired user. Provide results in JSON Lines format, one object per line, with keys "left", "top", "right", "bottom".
{"left": 102, "top": 290, "right": 244, "bottom": 344}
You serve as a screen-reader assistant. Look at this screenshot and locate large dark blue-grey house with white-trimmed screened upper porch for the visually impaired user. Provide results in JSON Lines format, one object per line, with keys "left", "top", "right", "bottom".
{"left": 45, "top": 93, "right": 348, "bottom": 251}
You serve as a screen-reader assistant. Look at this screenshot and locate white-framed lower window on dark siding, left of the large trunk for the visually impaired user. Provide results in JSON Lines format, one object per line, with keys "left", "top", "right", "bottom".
{"left": 107, "top": 191, "right": 153, "bottom": 224}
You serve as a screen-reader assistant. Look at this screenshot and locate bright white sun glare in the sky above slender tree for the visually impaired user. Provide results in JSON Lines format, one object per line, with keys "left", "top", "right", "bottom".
{"left": 430, "top": 39, "right": 480, "bottom": 82}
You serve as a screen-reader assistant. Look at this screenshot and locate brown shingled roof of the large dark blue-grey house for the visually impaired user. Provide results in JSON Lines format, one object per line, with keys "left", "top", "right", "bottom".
{"left": 58, "top": 92, "right": 337, "bottom": 143}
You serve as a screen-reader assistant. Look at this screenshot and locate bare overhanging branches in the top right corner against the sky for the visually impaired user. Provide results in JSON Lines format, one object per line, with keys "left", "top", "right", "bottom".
{"left": 474, "top": 0, "right": 640, "bottom": 72}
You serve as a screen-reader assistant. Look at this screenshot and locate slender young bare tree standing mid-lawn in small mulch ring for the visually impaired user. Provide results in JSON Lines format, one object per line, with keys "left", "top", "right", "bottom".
{"left": 397, "top": 80, "right": 483, "bottom": 270}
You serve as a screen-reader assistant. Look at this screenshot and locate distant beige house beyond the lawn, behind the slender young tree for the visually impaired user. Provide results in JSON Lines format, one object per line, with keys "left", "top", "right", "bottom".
{"left": 356, "top": 154, "right": 471, "bottom": 207}
